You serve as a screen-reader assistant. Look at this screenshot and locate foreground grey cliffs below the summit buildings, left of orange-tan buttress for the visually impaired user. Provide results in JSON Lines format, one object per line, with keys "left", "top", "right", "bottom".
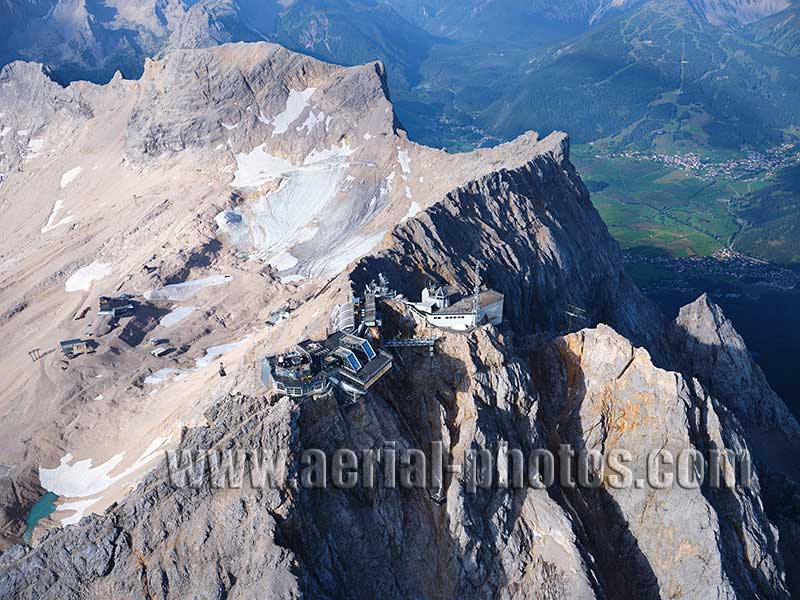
{"left": 0, "top": 331, "right": 594, "bottom": 598}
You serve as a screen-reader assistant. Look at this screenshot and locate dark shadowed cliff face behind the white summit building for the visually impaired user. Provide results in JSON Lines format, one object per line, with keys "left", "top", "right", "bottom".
{"left": 353, "top": 134, "right": 661, "bottom": 345}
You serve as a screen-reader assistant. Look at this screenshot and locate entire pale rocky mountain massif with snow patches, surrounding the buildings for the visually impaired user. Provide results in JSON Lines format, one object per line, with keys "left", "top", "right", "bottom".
{"left": 0, "top": 39, "right": 797, "bottom": 599}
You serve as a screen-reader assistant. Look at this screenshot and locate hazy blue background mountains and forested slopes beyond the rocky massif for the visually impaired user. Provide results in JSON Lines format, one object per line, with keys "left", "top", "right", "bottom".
{"left": 0, "top": 0, "right": 797, "bottom": 155}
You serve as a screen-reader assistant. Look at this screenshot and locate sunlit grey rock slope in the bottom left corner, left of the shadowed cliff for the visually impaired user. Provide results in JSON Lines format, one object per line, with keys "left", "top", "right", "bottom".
{"left": 0, "top": 398, "right": 299, "bottom": 599}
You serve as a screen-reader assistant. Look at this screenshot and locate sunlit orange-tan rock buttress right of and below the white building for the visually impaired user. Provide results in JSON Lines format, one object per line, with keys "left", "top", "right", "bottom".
{"left": 539, "top": 325, "right": 787, "bottom": 598}
